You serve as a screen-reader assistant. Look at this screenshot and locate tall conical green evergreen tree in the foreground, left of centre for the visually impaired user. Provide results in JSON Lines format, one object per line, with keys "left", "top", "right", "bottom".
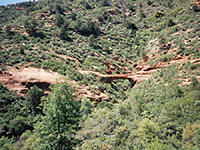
{"left": 35, "top": 83, "right": 80, "bottom": 150}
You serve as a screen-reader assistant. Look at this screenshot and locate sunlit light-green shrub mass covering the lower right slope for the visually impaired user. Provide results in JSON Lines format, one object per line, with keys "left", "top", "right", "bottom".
{"left": 79, "top": 68, "right": 200, "bottom": 150}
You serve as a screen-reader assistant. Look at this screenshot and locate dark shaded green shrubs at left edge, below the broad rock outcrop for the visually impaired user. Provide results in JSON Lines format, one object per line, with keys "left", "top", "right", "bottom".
{"left": 0, "top": 84, "right": 33, "bottom": 140}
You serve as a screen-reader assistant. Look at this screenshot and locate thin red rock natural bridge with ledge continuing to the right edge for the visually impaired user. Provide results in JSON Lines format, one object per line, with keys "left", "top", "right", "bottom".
{"left": 79, "top": 55, "right": 200, "bottom": 86}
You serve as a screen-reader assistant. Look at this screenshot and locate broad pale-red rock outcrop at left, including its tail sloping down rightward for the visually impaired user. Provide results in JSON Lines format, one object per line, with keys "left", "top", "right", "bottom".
{"left": 0, "top": 67, "right": 109, "bottom": 103}
